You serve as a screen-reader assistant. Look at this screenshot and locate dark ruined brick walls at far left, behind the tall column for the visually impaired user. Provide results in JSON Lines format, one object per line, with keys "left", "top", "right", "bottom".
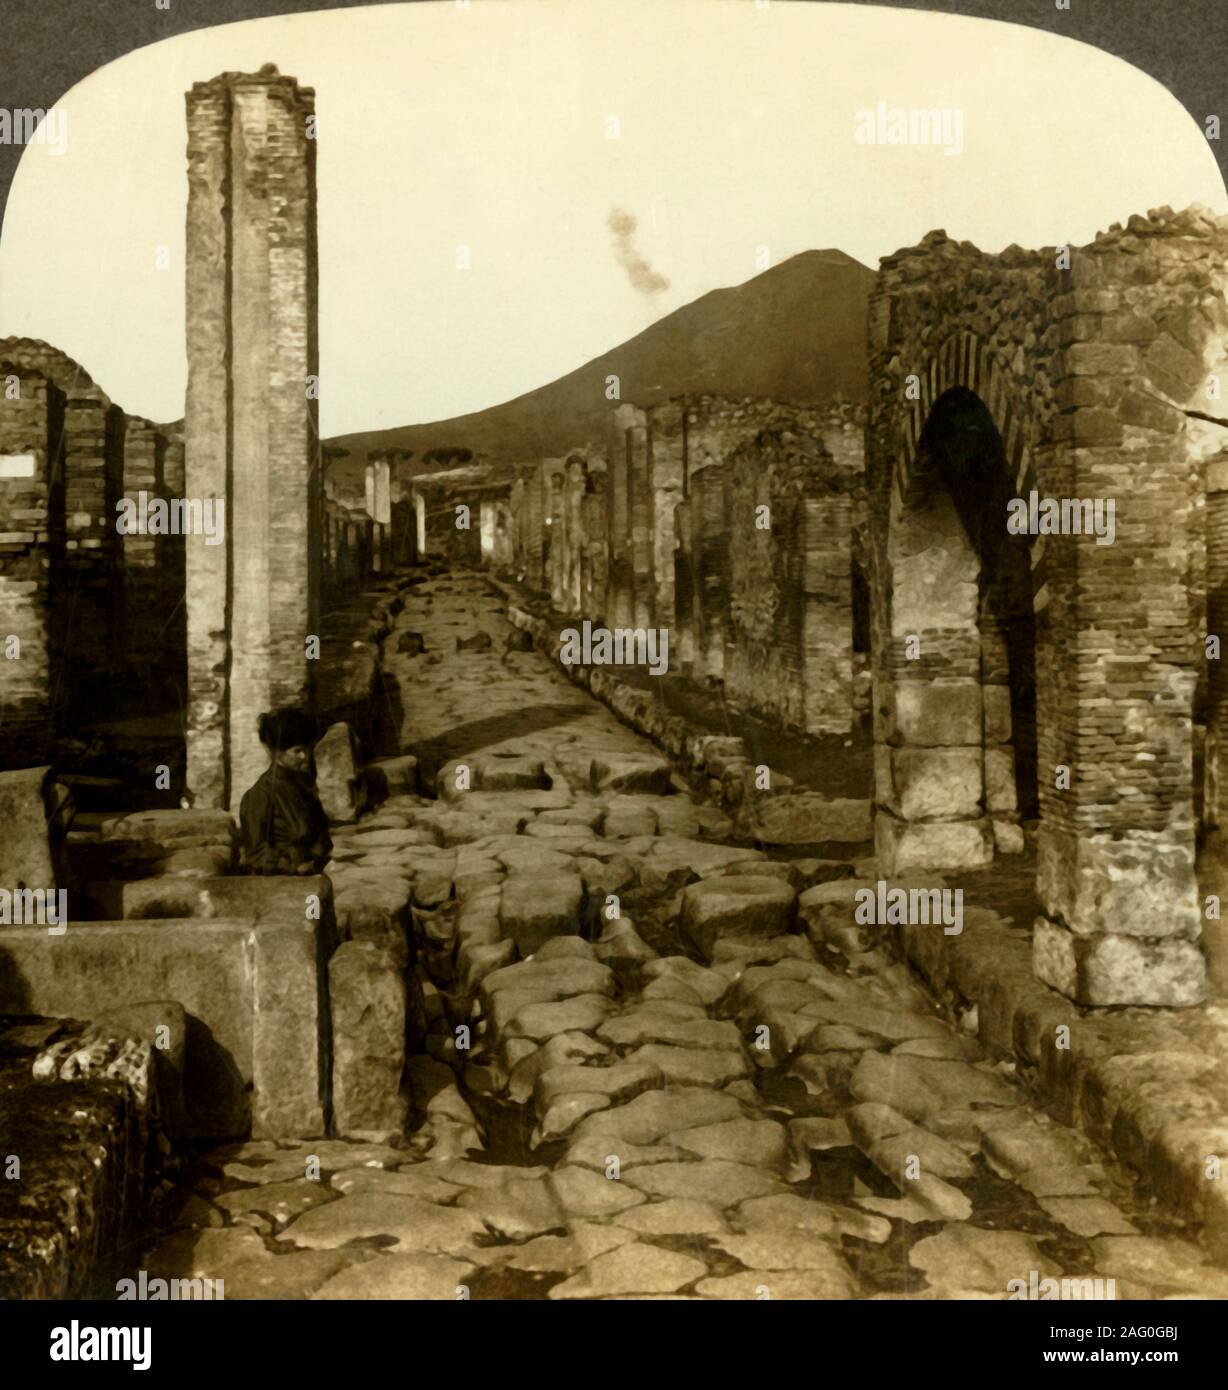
{"left": 0, "top": 338, "right": 184, "bottom": 766}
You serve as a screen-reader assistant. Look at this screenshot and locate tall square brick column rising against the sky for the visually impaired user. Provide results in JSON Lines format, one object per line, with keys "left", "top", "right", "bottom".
{"left": 185, "top": 65, "right": 320, "bottom": 806}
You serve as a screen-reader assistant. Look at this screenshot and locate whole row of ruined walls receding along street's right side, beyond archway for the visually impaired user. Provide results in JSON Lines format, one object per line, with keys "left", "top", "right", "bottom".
{"left": 497, "top": 396, "right": 865, "bottom": 734}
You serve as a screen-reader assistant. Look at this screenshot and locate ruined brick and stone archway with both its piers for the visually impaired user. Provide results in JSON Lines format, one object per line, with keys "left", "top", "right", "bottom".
{"left": 866, "top": 209, "right": 1228, "bottom": 1004}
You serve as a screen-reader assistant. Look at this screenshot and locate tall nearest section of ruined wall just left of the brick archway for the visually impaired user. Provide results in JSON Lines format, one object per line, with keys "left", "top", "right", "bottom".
{"left": 673, "top": 396, "right": 865, "bottom": 734}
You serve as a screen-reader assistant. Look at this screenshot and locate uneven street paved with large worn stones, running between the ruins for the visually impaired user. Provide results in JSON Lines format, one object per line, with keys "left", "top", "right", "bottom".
{"left": 142, "top": 574, "right": 1228, "bottom": 1300}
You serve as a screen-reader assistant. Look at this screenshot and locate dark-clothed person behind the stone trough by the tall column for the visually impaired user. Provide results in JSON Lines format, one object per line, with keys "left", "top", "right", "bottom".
{"left": 239, "top": 709, "right": 332, "bottom": 874}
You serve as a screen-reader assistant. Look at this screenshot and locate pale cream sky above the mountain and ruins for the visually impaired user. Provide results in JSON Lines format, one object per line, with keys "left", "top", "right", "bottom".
{"left": 0, "top": 0, "right": 1228, "bottom": 435}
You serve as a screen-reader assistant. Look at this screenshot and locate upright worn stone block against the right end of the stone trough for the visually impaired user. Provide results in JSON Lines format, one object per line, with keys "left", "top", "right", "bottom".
{"left": 328, "top": 941, "right": 409, "bottom": 1143}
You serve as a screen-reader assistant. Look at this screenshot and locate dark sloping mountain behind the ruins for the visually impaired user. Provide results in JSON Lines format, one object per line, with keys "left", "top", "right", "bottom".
{"left": 327, "top": 250, "right": 875, "bottom": 475}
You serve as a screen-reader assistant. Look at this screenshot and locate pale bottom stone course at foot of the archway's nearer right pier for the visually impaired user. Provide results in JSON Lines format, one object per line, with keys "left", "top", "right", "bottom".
{"left": 1032, "top": 917, "right": 1207, "bottom": 1008}
